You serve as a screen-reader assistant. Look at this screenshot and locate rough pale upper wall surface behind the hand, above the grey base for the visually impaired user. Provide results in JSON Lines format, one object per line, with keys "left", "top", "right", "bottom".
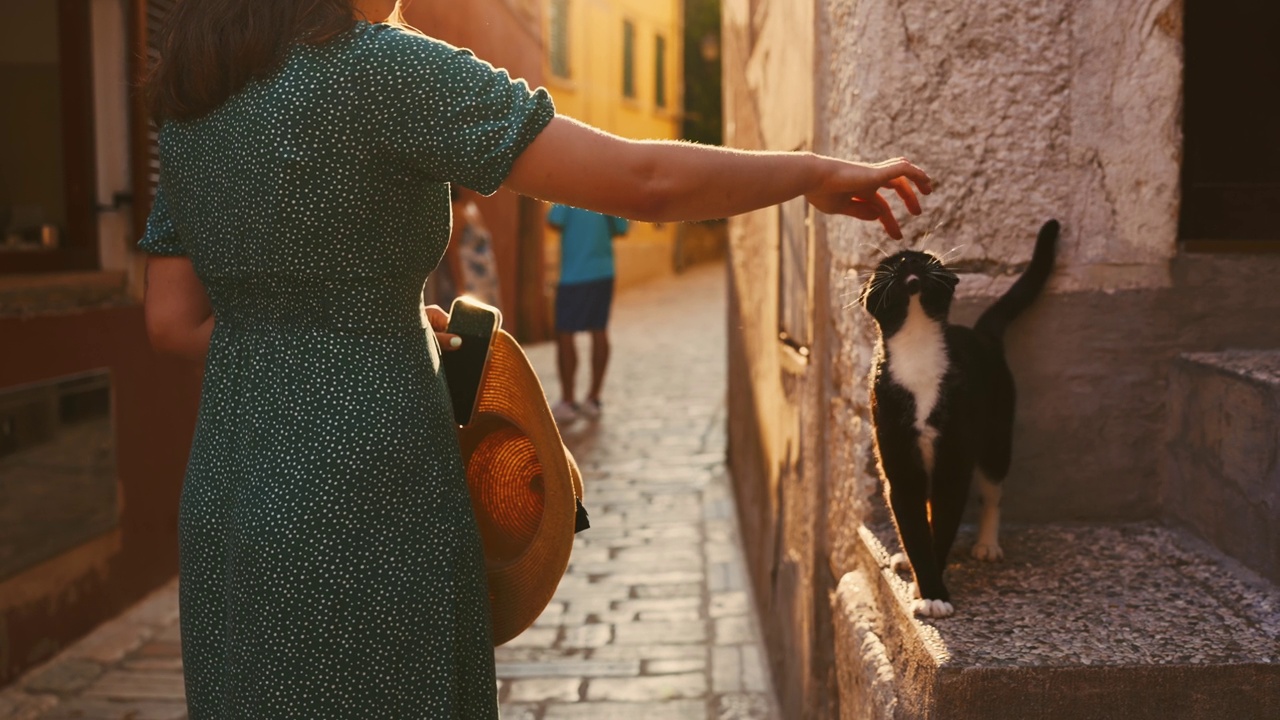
{"left": 818, "top": 0, "right": 1181, "bottom": 290}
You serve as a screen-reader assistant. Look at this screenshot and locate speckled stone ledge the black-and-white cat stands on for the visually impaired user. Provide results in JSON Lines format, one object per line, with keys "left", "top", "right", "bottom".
{"left": 832, "top": 515, "right": 1280, "bottom": 720}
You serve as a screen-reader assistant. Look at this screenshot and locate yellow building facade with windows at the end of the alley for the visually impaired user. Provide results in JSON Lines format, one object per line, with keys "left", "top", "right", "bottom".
{"left": 543, "top": 0, "right": 684, "bottom": 288}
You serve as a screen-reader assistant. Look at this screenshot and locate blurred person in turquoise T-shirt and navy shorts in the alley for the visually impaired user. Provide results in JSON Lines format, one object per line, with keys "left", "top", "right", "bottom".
{"left": 547, "top": 205, "right": 627, "bottom": 423}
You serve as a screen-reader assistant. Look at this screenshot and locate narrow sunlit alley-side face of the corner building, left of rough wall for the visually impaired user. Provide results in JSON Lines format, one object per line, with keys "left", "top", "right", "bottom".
{"left": 722, "top": 0, "right": 836, "bottom": 717}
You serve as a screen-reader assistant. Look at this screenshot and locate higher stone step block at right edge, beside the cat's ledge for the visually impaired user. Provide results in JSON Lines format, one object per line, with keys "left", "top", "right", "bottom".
{"left": 1164, "top": 351, "right": 1280, "bottom": 583}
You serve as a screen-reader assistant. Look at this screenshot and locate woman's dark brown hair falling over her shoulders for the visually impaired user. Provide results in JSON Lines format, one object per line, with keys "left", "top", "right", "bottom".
{"left": 146, "top": 0, "right": 356, "bottom": 122}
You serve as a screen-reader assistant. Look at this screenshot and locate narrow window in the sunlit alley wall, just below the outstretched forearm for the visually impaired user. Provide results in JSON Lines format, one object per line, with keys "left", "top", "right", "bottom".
{"left": 778, "top": 197, "right": 813, "bottom": 357}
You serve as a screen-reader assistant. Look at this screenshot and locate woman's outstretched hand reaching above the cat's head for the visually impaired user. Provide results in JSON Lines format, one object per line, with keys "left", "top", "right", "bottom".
{"left": 805, "top": 158, "right": 933, "bottom": 240}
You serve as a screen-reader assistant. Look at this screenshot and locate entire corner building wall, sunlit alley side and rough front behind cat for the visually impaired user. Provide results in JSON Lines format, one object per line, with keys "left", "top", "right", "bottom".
{"left": 723, "top": 0, "right": 1280, "bottom": 716}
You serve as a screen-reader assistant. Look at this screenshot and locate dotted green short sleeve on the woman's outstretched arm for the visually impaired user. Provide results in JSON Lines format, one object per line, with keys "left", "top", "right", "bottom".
{"left": 367, "top": 26, "right": 556, "bottom": 195}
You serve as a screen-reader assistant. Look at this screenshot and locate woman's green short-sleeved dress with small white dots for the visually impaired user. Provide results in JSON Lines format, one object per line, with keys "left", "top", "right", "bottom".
{"left": 141, "top": 23, "right": 554, "bottom": 720}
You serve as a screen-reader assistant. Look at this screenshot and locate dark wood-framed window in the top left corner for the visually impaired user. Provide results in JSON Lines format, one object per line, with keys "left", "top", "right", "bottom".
{"left": 0, "top": 0, "right": 97, "bottom": 273}
